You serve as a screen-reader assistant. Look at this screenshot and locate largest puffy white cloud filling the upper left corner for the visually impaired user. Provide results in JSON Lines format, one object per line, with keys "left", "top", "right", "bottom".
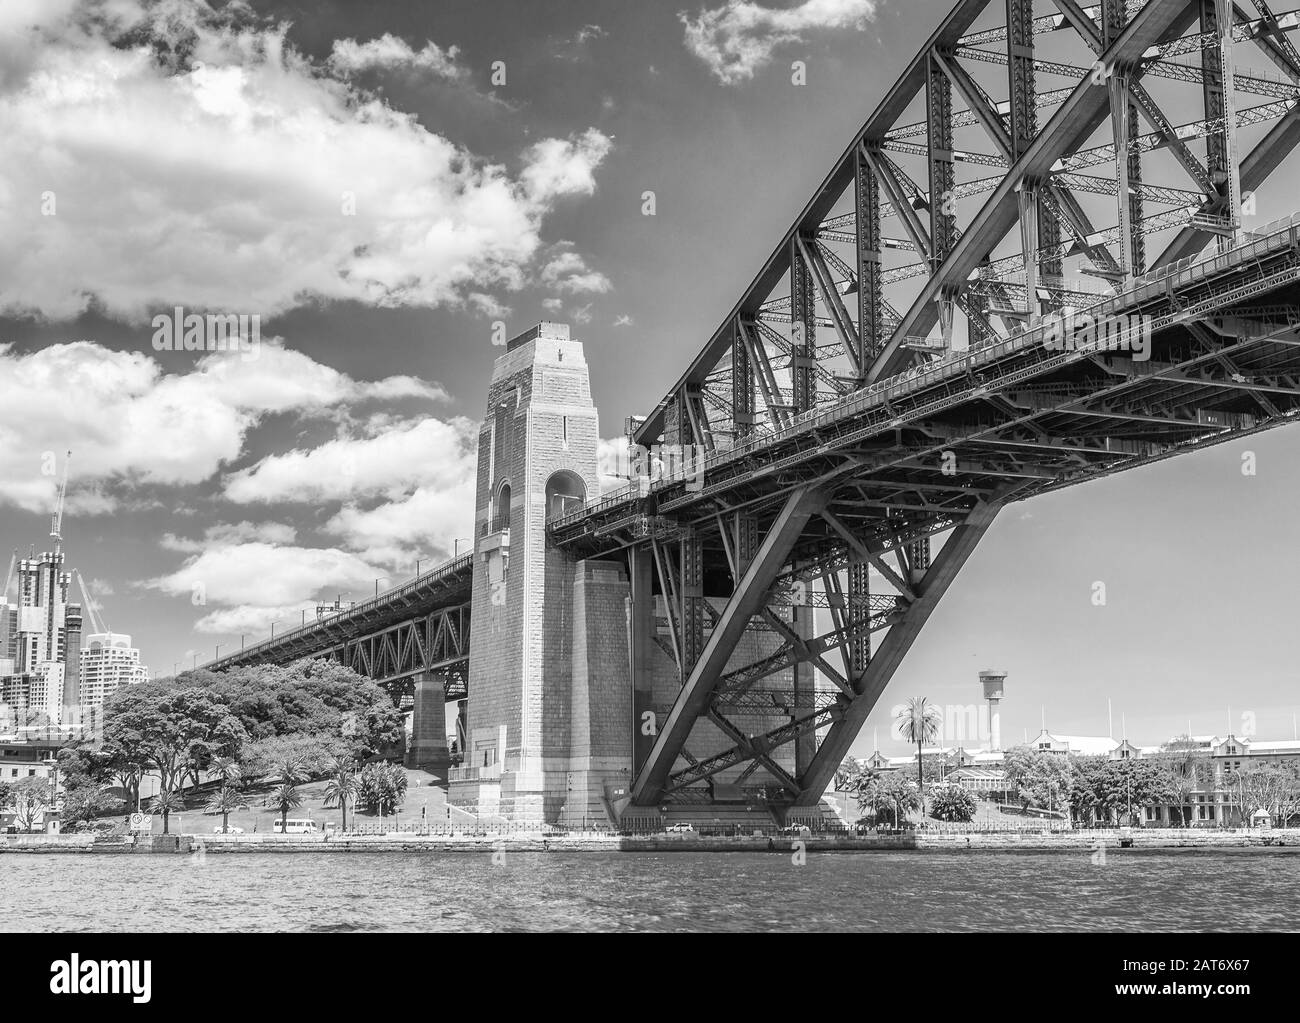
{"left": 0, "top": 0, "right": 612, "bottom": 322}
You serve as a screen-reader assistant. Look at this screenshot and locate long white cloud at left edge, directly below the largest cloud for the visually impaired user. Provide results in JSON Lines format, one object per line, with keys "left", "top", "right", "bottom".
{"left": 0, "top": 341, "right": 446, "bottom": 513}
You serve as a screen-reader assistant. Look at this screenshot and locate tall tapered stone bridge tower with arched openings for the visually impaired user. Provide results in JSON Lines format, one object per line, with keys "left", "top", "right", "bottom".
{"left": 450, "top": 324, "right": 632, "bottom": 824}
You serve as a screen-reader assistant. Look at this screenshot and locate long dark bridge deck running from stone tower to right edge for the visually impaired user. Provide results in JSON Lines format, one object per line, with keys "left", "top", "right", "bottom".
{"left": 550, "top": 214, "right": 1300, "bottom": 569}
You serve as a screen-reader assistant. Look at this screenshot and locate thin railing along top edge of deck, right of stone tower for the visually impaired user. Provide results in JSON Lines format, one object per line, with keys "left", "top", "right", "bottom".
{"left": 549, "top": 213, "right": 1300, "bottom": 526}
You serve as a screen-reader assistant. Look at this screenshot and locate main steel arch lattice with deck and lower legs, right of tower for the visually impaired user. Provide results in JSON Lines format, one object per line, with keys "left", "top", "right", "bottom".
{"left": 553, "top": 0, "right": 1300, "bottom": 805}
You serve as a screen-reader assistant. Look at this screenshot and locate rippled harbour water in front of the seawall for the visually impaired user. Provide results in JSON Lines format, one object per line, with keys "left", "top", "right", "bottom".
{"left": 0, "top": 851, "right": 1300, "bottom": 931}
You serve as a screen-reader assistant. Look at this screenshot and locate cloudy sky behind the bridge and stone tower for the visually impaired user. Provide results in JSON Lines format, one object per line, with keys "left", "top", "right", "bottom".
{"left": 0, "top": 0, "right": 1300, "bottom": 753}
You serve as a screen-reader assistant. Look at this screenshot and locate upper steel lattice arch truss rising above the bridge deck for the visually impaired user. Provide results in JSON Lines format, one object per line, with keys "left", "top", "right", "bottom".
{"left": 636, "top": 0, "right": 1300, "bottom": 443}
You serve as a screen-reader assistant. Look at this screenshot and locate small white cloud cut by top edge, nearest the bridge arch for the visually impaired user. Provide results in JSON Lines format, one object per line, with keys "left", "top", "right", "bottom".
{"left": 679, "top": 0, "right": 876, "bottom": 86}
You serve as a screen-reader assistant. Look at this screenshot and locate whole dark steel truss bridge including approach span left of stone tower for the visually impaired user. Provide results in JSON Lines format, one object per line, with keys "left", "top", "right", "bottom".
{"left": 208, "top": 0, "right": 1300, "bottom": 807}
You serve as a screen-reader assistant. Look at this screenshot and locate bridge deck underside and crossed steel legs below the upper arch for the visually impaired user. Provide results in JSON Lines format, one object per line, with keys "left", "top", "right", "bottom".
{"left": 553, "top": 227, "right": 1300, "bottom": 807}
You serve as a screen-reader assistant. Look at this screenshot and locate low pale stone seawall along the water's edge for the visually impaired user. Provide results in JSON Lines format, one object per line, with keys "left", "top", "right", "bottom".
{"left": 0, "top": 828, "right": 1300, "bottom": 855}
